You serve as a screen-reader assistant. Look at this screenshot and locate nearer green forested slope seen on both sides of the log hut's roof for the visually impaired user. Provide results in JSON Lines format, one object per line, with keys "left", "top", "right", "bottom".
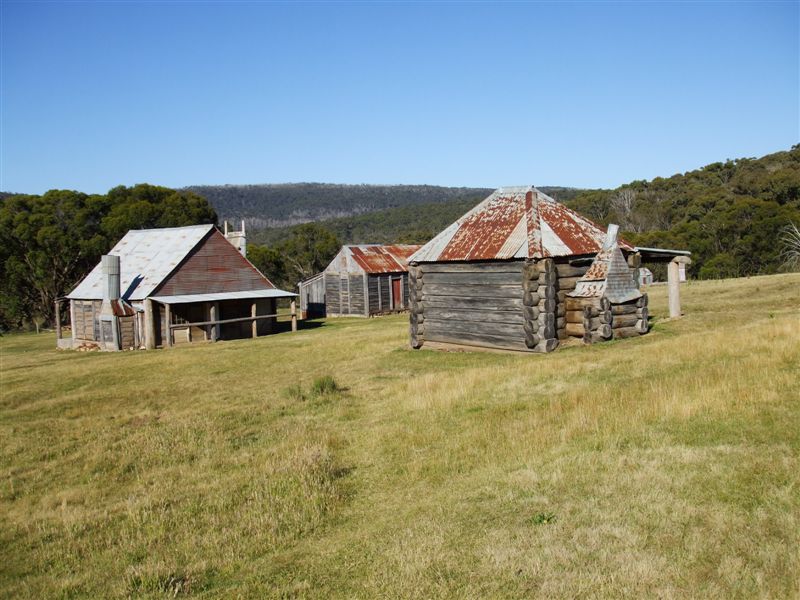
{"left": 251, "top": 145, "right": 800, "bottom": 279}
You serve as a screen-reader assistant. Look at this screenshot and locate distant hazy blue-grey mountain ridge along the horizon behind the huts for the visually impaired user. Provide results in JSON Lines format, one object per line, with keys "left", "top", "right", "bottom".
{"left": 185, "top": 183, "right": 580, "bottom": 230}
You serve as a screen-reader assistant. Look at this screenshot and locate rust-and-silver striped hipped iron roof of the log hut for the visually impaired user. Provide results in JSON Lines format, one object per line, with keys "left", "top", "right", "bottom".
{"left": 409, "top": 186, "right": 633, "bottom": 262}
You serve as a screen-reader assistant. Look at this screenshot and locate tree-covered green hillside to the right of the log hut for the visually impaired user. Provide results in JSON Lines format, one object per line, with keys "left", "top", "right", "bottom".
{"left": 566, "top": 145, "right": 800, "bottom": 279}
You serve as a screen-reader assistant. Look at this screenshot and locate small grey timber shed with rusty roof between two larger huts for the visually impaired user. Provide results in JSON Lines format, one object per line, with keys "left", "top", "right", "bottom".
{"left": 298, "top": 244, "right": 420, "bottom": 318}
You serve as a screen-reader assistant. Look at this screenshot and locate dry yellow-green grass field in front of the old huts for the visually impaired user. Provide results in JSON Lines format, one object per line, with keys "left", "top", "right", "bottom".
{"left": 0, "top": 274, "right": 800, "bottom": 599}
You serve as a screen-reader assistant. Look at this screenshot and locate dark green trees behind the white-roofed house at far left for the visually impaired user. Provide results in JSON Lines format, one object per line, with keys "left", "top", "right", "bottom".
{"left": 0, "top": 184, "right": 217, "bottom": 330}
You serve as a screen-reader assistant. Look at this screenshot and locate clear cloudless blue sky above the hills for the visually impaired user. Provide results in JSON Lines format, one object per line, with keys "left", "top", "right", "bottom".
{"left": 0, "top": 0, "right": 800, "bottom": 193}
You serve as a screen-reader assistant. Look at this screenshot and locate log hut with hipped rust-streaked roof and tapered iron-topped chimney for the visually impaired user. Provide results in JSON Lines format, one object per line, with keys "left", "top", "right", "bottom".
{"left": 409, "top": 186, "right": 688, "bottom": 352}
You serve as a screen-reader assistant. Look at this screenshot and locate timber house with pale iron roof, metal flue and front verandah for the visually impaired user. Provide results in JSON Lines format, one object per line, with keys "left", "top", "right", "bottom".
{"left": 57, "top": 225, "right": 296, "bottom": 350}
